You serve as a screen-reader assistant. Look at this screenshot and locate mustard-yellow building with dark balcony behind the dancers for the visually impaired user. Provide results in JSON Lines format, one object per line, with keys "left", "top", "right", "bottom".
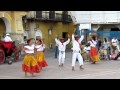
{"left": 23, "top": 11, "right": 76, "bottom": 48}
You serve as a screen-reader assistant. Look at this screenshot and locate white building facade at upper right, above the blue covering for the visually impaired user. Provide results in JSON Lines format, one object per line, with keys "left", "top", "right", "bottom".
{"left": 70, "top": 11, "right": 120, "bottom": 40}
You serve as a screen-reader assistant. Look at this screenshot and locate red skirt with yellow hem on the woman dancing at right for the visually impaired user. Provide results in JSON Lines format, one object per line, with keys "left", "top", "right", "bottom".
{"left": 89, "top": 47, "right": 100, "bottom": 62}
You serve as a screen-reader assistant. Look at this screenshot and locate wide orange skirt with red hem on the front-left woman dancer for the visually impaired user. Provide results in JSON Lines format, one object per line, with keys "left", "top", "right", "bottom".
{"left": 22, "top": 55, "right": 41, "bottom": 74}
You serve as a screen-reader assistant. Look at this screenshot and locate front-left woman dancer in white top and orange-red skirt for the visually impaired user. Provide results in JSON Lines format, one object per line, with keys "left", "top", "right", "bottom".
{"left": 22, "top": 39, "right": 41, "bottom": 76}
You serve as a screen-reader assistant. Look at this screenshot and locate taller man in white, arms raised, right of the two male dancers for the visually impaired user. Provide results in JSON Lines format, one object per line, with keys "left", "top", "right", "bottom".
{"left": 72, "top": 34, "right": 84, "bottom": 71}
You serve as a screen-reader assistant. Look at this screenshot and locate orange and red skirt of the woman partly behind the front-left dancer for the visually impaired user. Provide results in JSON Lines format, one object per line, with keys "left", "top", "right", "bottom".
{"left": 36, "top": 52, "right": 48, "bottom": 67}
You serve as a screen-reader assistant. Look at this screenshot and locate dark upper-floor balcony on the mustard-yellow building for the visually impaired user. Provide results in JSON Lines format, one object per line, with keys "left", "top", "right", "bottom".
{"left": 26, "top": 11, "right": 72, "bottom": 23}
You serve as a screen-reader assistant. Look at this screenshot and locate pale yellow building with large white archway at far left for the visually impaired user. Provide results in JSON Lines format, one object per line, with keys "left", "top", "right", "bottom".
{"left": 0, "top": 11, "right": 27, "bottom": 41}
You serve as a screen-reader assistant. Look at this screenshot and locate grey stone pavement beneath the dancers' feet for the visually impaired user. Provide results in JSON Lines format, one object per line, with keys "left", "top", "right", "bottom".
{"left": 0, "top": 50, "right": 120, "bottom": 79}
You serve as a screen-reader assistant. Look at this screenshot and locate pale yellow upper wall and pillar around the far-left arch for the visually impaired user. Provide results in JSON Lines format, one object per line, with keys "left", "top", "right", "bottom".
{"left": 0, "top": 11, "right": 27, "bottom": 33}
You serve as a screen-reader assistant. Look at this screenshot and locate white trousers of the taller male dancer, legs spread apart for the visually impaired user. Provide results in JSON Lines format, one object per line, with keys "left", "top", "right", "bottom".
{"left": 72, "top": 52, "right": 83, "bottom": 67}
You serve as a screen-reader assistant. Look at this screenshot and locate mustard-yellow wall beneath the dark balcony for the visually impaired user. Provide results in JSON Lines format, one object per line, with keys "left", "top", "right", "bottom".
{"left": 36, "top": 21, "right": 75, "bottom": 48}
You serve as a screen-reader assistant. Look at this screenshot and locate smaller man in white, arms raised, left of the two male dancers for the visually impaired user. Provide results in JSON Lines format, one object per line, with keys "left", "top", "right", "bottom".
{"left": 55, "top": 34, "right": 70, "bottom": 67}
